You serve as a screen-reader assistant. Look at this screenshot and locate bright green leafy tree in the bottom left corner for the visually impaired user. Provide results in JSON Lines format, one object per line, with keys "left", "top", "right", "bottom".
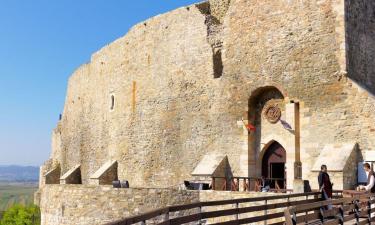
{"left": 0, "top": 205, "right": 40, "bottom": 225}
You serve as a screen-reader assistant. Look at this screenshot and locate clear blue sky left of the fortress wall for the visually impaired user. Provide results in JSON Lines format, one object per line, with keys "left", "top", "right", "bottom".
{"left": 0, "top": 0, "right": 199, "bottom": 165}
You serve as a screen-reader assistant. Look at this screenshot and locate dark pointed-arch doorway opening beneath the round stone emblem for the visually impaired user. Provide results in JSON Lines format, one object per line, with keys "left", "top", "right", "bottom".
{"left": 262, "top": 141, "right": 286, "bottom": 189}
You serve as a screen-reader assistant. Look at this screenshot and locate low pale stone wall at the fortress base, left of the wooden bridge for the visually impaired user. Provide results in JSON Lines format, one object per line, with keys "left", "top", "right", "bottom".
{"left": 40, "top": 185, "right": 199, "bottom": 225}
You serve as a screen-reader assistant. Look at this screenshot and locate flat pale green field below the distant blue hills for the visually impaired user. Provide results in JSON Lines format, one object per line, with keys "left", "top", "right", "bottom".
{"left": 0, "top": 183, "right": 38, "bottom": 211}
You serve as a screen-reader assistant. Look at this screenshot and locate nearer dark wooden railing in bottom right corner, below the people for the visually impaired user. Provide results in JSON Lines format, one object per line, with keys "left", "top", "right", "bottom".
{"left": 285, "top": 194, "right": 375, "bottom": 225}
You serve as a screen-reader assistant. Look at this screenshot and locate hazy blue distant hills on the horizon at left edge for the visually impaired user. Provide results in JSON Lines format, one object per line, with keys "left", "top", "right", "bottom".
{"left": 0, "top": 165, "right": 39, "bottom": 182}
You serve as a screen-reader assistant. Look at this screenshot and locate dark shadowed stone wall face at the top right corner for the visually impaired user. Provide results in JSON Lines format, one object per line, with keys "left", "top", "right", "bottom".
{"left": 345, "top": 0, "right": 375, "bottom": 95}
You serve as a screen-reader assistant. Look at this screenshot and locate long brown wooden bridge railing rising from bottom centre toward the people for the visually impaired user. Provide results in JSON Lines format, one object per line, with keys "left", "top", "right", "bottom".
{"left": 107, "top": 191, "right": 342, "bottom": 225}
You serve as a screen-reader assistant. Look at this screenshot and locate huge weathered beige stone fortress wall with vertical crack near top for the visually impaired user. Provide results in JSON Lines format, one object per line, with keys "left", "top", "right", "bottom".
{"left": 41, "top": 0, "right": 375, "bottom": 224}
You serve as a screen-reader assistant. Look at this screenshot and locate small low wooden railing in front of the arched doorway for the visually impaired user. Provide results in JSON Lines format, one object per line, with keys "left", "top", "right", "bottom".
{"left": 212, "top": 177, "right": 293, "bottom": 193}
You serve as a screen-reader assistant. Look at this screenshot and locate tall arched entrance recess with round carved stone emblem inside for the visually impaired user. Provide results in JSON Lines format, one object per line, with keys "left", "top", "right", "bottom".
{"left": 248, "top": 86, "right": 286, "bottom": 179}
